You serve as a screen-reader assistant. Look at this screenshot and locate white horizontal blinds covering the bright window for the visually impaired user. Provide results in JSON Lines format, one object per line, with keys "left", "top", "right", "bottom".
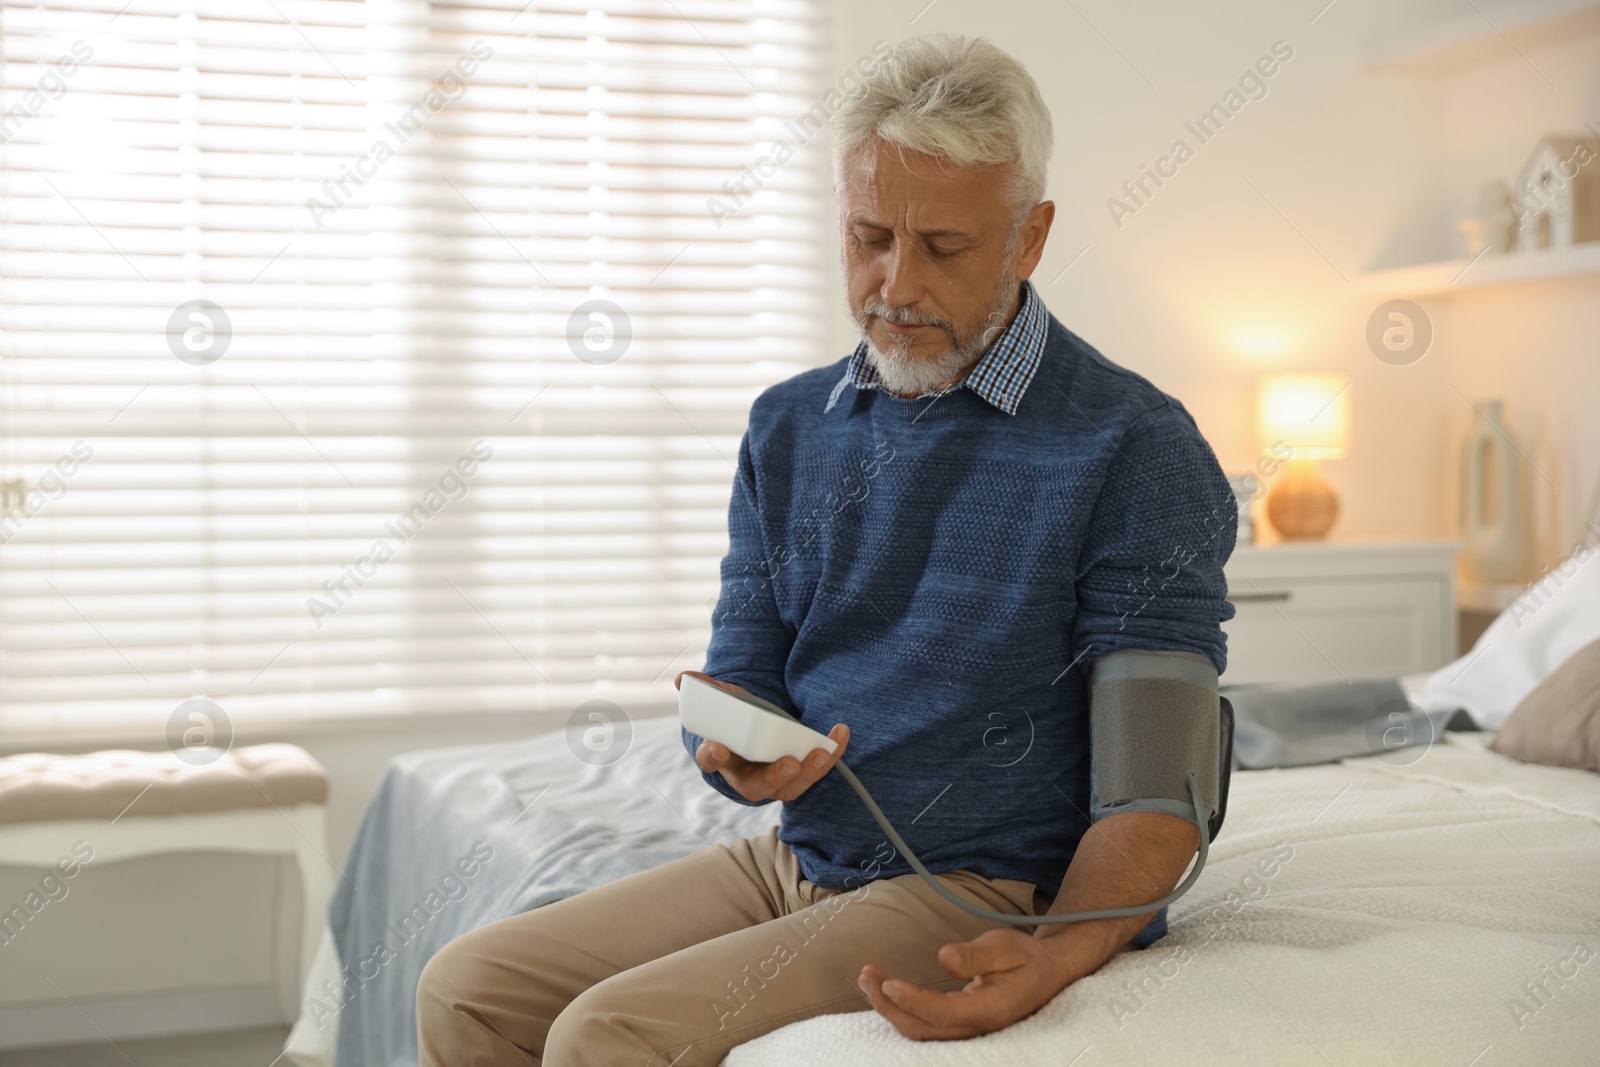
{"left": 0, "top": 0, "right": 832, "bottom": 737}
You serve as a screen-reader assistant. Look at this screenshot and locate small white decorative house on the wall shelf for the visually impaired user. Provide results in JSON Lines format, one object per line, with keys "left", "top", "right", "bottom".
{"left": 1510, "top": 130, "right": 1600, "bottom": 251}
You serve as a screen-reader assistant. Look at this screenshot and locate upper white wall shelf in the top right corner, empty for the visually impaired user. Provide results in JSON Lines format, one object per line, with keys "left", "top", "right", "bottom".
{"left": 1366, "top": 0, "right": 1600, "bottom": 74}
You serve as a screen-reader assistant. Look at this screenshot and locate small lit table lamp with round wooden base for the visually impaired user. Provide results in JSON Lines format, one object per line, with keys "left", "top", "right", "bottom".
{"left": 1258, "top": 373, "right": 1350, "bottom": 541}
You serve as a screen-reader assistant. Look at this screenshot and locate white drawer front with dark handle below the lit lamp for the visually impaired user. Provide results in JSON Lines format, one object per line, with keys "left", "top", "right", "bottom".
{"left": 1222, "top": 577, "right": 1448, "bottom": 685}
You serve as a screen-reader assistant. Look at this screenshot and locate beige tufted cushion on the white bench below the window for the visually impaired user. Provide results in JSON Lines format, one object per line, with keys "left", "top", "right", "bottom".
{"left": 0, "top": 744, "right": 328, "bottom": 824}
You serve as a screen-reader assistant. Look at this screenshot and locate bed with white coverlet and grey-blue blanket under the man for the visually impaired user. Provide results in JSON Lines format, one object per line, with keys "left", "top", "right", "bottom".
{"left": 286, "top": 703, "right": 1600, "bottom": 1067}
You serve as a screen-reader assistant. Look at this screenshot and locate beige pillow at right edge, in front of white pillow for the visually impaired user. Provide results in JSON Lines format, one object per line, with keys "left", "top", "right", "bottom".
{"left": 1490, "top": 641, "right": 1600, "bottom": 773}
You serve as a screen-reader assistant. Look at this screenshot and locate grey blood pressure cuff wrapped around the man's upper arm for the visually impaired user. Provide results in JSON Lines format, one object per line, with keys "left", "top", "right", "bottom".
{"left": 1090, "top": 649, "right": 1232, "bottom": 838}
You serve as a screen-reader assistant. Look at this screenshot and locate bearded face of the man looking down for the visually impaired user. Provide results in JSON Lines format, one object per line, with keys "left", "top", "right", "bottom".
{"left": 838, "top": 141, "right": 1054, "bottom": 395}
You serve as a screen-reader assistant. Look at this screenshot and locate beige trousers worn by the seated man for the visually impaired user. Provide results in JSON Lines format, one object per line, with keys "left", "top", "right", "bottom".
{"left": 416, "top": 830, "right": 1051, "bottom": 1067}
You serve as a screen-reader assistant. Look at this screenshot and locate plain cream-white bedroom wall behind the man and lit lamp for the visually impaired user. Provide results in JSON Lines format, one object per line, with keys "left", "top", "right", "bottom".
{"left": 12, "top": 0, "right": 1600, "bottom": 1043}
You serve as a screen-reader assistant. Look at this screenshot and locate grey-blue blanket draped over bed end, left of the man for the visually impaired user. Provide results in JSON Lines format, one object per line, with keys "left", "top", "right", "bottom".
{"left": 324, "top": 717, "right": 778, "bottom": 1067}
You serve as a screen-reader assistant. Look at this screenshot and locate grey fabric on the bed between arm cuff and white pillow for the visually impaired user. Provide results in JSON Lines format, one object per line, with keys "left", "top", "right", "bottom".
{"left": 1222, "top": 678, "right": 1477, "bottom": 771}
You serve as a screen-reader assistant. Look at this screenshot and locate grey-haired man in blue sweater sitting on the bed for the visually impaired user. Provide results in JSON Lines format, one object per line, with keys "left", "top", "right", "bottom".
{"left": 418, "top": 37, "right": 1235, "bottom": 1067}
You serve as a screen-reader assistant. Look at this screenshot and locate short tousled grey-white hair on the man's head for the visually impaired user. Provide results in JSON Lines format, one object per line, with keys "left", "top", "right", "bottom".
{"left": 832, "top": 34, "right": 1053, "bottom": 219}
